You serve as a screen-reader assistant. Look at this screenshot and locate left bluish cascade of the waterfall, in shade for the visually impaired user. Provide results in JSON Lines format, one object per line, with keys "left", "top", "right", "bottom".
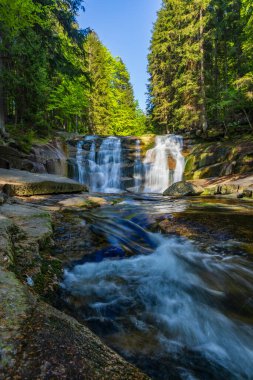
{"left": 76, "top": 136, "right": 121, "bottom": 193}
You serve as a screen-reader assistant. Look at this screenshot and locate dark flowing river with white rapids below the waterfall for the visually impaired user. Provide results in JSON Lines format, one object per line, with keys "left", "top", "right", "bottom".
{"left": 58, "top": 194, "right": 253, "bottom": 380}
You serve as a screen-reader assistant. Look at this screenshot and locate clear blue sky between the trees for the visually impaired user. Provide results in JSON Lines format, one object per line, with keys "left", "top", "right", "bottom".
{"left": 79, "top": 0, "right": 161, "bottom": 110}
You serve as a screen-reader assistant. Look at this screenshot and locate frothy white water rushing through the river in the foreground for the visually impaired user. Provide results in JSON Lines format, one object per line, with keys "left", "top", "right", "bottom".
{"left": 64, "top": 234, "right": 253, "bottom": 379}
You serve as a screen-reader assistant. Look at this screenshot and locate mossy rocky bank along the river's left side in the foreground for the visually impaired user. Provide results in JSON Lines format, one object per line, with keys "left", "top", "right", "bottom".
{"left": 0, "top": 189, "right": 147, "bottom": 380}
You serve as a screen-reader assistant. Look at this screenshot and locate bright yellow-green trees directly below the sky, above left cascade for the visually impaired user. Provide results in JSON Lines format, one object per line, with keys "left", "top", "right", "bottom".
{"left": 85, "top": 32, "right": 146, "bottom": 136}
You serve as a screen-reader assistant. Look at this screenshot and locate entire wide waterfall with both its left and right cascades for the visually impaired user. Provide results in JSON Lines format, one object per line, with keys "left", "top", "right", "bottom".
{"left": 75, "top": 135, "right": 185, "bottom": 193}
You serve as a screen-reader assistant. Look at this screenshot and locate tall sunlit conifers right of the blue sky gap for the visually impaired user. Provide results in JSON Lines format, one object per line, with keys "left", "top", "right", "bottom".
{"left": 148, "top": 0, "right": 253, "bottom": 132}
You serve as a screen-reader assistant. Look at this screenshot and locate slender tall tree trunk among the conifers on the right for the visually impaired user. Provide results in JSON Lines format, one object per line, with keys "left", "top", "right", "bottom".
{"left": 199, "top": 6, "right": 208, "bottom": 133}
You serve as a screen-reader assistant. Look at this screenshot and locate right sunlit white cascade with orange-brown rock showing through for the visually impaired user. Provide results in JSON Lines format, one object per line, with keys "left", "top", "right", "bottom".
{"left": 143, "top": 135, "right": 185, "bottom": 193}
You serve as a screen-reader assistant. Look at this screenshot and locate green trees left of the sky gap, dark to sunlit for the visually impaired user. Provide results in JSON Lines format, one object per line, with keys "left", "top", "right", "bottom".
{"left": 0, "top": 0, "right": 145, "bottom": 135}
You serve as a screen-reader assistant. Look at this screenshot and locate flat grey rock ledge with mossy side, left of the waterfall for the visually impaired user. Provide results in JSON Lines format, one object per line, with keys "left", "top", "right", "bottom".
{"left": 0, "top": 169, "right": 87, "bottom": 196}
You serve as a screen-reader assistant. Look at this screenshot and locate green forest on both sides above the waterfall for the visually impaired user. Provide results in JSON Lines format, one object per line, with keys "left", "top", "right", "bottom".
{"left": 0, "top": 0, "right": 253, "bottom": 135}
